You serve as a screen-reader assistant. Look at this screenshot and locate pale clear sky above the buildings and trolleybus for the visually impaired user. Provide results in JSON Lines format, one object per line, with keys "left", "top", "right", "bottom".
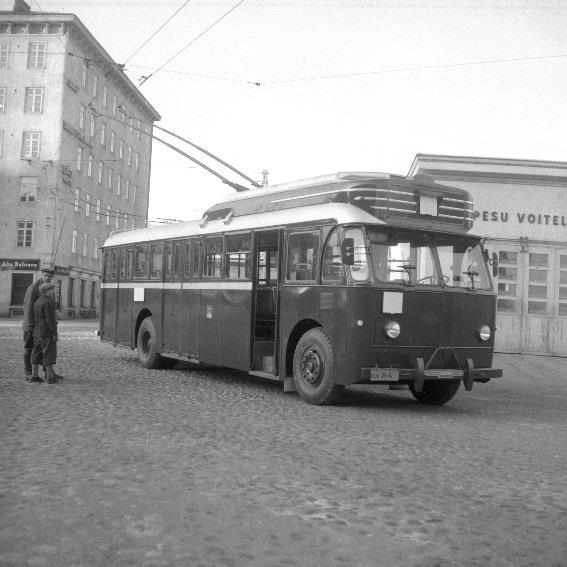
{"left": 10, "top": 0, "right": 567, "bottom": 220}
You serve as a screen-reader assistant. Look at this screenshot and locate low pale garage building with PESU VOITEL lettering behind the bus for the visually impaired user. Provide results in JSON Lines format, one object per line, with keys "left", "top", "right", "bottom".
{"left": 409, "top": 154, "right": 567, "bottom": 356}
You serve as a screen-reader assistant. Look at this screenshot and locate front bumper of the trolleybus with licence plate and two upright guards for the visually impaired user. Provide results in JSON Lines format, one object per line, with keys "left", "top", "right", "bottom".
{"left": 361, "top": 358, "right": 502, "bottom": 392}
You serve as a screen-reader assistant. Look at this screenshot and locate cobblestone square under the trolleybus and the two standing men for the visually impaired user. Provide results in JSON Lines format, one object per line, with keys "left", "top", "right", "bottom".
{"left": 0, "top": 321, "right": 567, "bottom": 567}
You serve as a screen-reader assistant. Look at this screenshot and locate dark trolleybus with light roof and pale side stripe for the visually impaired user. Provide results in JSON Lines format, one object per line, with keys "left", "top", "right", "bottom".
{"left": 100, "top": 173, "right": 502, "bottom": 404}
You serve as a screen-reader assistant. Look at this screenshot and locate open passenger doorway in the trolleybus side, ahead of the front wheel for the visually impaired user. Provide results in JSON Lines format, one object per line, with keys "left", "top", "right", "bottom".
{"left": 251, "top": 230, "right": 281, "bottom": 375}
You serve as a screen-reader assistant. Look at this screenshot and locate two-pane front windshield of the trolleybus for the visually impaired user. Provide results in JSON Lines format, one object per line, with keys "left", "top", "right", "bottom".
{"left": 364, "top": 229, "right": 491, "bottom": 290}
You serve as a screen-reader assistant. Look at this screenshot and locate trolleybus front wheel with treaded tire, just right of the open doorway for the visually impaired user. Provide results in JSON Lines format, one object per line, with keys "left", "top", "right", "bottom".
{"left": 293, "top": 328, "right": 345, "bottom": 405}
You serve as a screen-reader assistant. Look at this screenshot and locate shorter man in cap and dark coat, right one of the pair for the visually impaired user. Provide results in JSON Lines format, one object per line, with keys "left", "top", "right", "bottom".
{"left": 31, "top": 283, "right": 63, "bottom": 384}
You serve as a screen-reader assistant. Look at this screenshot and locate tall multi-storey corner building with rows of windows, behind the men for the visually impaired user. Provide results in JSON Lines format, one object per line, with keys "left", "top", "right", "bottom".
{"left": 0, "top": 0, "right": 160, "bottom": 318}
